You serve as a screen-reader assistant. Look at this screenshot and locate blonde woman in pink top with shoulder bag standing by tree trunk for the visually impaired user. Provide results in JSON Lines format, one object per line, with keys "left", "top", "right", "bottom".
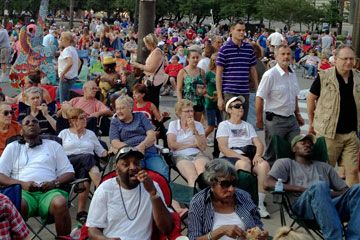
{"left": 132, "top": 33, "right": 165, "bottom": 108}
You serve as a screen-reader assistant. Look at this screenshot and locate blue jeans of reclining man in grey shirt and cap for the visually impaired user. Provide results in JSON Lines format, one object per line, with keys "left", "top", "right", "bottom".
{"left": 293, "top": 181, "right": 360, "bottom": 240}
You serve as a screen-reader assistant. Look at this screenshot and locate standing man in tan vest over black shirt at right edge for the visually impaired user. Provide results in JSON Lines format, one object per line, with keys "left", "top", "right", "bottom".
{"left": 307, "top": 45, "right": 360, "bottom": 186}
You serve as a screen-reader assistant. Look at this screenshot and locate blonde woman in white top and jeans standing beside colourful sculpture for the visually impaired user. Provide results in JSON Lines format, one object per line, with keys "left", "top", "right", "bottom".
{"left": 56, "top": 32, "right": 81, "bottom": 103}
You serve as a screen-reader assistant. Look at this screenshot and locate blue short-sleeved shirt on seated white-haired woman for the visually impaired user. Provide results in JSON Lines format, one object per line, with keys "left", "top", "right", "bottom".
{"left": 110, "top": 113, "right": 156, "bottom": 154}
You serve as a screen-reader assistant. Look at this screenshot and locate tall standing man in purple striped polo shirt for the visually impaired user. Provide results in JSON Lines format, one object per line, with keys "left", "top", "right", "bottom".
{"left": 216, "top": 20, "right": 258, "bottom": 121}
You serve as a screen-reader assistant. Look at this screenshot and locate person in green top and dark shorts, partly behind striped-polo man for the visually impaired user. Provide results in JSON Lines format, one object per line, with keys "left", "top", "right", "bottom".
{"left": 204, "top": 53, "right": 222, "bottom": 146}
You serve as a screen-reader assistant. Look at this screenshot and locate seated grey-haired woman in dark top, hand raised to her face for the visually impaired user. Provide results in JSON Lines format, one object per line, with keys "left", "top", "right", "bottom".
{"left": 17, "top": 87, "right": 57, "bottom": 134}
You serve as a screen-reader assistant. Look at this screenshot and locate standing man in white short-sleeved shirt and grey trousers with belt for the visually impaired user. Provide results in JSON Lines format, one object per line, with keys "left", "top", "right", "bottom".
{"left": 255, "top": 45, "right": 304, "bottom": 165}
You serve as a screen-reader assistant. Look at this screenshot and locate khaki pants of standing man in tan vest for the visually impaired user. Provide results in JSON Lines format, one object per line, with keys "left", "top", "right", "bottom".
{"left": 325, "top": 131, "right": 359, "bottom": 169}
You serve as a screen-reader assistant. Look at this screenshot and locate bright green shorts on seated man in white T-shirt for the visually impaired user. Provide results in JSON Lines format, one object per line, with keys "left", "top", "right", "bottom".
{"left": 21, "top": 189, "right": 69, "bottom": 223}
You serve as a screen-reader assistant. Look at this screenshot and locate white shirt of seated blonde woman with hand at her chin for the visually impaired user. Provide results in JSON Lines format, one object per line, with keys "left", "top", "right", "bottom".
{"left": 166, "top": 120, "right": 205, "bottom": 155}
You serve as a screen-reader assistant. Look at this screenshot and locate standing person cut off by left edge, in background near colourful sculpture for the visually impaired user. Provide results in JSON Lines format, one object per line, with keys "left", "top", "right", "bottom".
{"left": 0, "top": 24, "right": 11, "bottom": 83}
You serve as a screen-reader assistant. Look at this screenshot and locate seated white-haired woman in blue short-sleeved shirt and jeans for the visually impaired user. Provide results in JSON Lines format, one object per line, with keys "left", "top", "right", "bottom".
{"left": 109, "top": 96, "right": 169, "bottom": 180}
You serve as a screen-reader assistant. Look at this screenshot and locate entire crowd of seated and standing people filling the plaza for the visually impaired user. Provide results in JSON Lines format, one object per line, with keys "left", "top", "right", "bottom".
{"left": 0, "top": 15, "right": 360, "bottom": 240}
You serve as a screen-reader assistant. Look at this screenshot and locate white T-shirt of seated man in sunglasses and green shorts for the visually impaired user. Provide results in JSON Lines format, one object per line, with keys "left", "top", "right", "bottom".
{"left": 0, "top": 139, "right": 74, "bottom": 183}
